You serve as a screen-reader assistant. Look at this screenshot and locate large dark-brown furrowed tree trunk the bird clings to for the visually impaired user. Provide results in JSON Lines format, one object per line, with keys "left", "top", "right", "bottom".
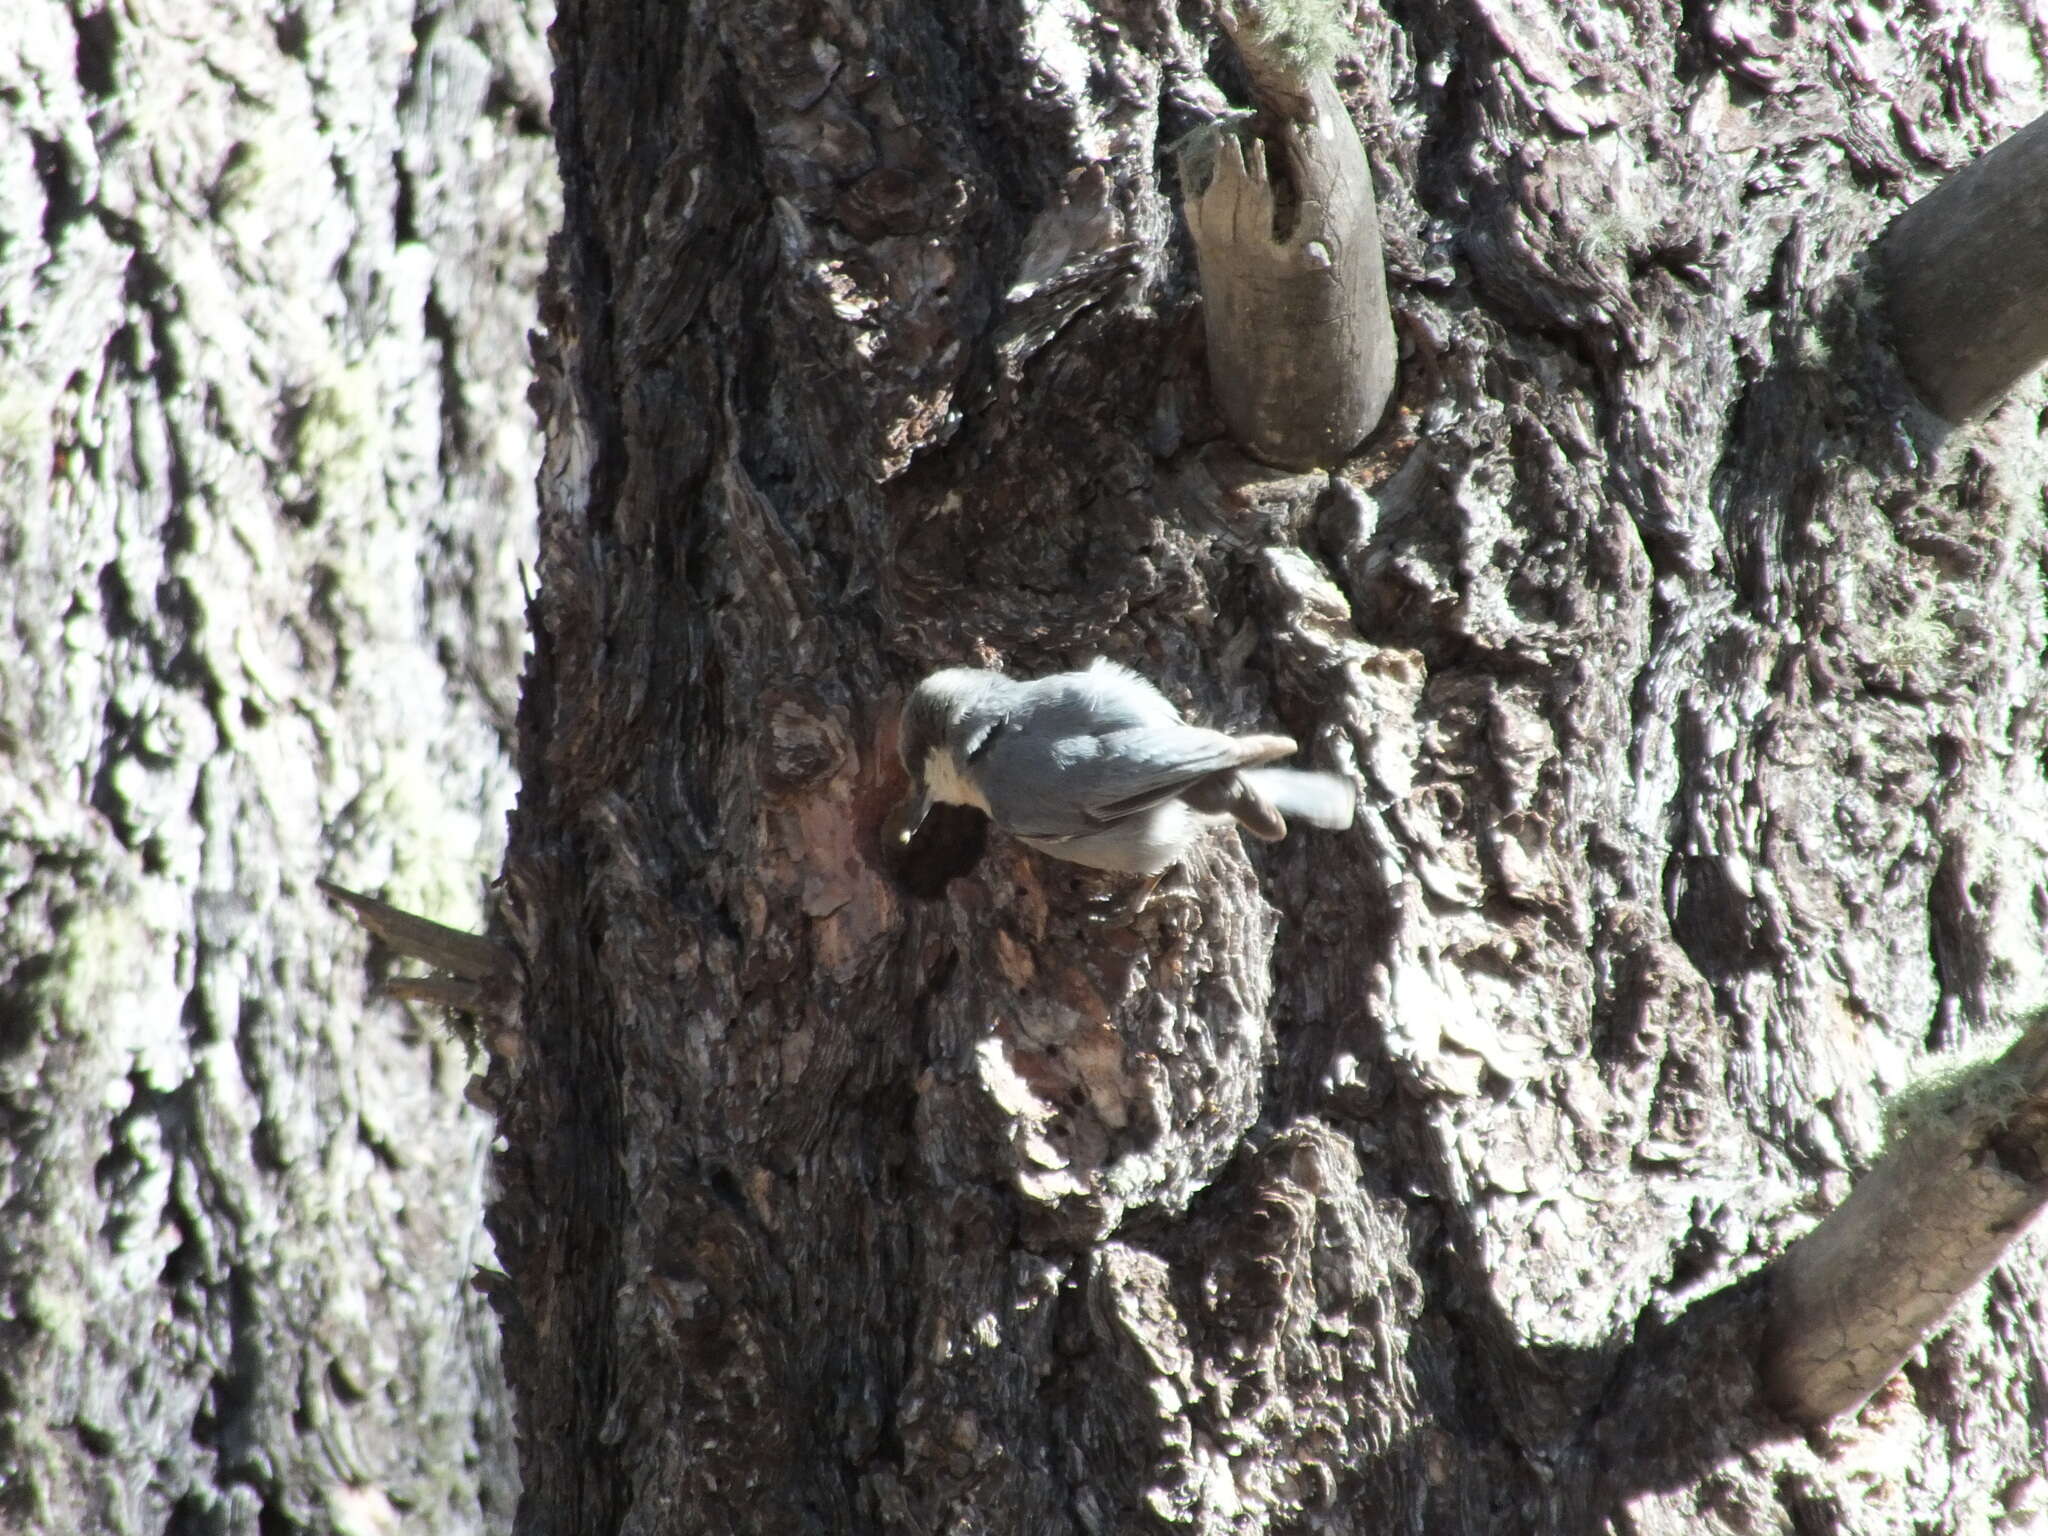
{"left": 503, "top": 0, "right": 2048, "bottom": 1534}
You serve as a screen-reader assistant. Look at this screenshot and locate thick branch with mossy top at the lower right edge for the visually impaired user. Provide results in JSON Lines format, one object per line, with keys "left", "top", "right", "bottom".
{"left": 1763, "top": 1018, "right": 2048, "bottom": 1427}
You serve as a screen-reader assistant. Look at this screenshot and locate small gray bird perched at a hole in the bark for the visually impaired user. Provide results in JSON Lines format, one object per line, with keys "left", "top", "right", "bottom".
{"left": 897, "top": 659, "right": 1352, "bottom": 874}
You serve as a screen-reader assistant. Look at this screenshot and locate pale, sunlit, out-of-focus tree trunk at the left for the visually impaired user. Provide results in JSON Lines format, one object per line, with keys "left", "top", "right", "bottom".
{"left": 0, "top": 0, "right": 555, "bottom": 1536}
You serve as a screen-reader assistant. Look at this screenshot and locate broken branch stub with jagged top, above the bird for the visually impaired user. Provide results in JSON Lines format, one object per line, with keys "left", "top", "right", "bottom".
{"left": 1180, "top": 66, "right": 1395, "bottom": 469}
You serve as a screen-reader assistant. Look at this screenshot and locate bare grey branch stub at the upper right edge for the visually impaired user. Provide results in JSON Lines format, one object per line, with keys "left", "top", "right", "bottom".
{"left": 1876, "top": 117, "right": 2048, "bottom": 422}
